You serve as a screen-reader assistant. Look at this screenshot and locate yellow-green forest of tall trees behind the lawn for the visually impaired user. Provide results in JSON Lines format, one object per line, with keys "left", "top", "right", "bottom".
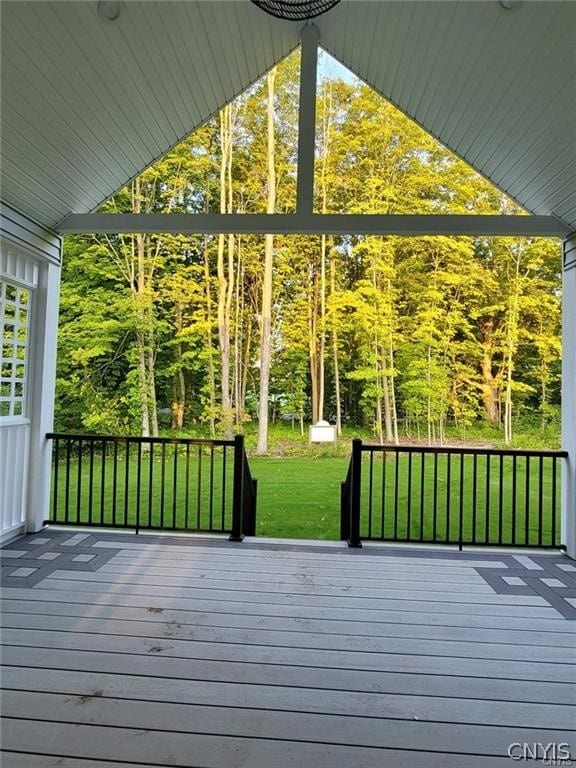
{"left": 56, "top": 52, "right": 561, "bottom": 453}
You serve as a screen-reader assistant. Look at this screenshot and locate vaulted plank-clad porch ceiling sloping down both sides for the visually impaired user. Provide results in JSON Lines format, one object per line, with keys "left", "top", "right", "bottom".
{"left": 1, "top": 0, "right": 576, "bottom": 231}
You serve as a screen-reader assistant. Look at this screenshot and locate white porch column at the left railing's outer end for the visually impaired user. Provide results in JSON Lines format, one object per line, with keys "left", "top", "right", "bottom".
{"left": 26, "top": 255, "right": 60, "bottom": 533}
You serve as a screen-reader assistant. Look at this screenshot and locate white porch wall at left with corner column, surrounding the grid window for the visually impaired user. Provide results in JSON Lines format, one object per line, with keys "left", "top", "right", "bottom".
{"left": 0, "top": 205, "right": 60, "bottom": 540}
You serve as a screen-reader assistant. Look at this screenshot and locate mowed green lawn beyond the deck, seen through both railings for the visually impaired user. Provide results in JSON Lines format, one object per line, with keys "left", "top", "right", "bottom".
{"left": 52, "top": 446, "right": 560, "bottom": 545}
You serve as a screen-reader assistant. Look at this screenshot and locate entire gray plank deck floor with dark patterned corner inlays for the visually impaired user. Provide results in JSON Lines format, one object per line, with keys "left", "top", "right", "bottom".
{"left": 2, "top": 529, "right": 576, "bottom": 768}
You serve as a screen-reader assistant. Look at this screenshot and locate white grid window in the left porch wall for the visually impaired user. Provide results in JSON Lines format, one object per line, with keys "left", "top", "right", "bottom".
{"left": 0, "top": 280, "right": 30, "bottom": 418}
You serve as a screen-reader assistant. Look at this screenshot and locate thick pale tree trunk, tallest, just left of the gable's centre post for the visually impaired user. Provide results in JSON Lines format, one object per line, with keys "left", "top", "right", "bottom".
{"left": 256, "top": 67, "right": 276, "bottom": 456}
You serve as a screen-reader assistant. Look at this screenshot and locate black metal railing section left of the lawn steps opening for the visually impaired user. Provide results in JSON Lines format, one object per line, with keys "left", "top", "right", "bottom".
{"left": 46, "top": 433, "right": 256, "bottom": 541}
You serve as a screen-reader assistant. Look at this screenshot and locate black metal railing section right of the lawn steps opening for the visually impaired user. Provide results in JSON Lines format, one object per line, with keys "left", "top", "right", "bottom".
{"left": 340, "top": 440, "right": 568, "bottom": 548}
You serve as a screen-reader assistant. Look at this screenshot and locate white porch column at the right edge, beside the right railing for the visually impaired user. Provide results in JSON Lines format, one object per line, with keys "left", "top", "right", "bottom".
{"left": 562, "top": 234, "right": 576, "bottom": 559}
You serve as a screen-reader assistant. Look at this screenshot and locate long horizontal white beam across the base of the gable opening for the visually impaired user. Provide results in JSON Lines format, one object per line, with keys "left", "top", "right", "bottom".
{"left": 58, "top": 213, "right": 570, "bottom": 239}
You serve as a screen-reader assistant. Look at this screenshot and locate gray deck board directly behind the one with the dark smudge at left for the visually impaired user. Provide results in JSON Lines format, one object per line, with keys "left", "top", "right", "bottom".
{"left": 3, "top": 667, "right": 576, "bottom": 729}
